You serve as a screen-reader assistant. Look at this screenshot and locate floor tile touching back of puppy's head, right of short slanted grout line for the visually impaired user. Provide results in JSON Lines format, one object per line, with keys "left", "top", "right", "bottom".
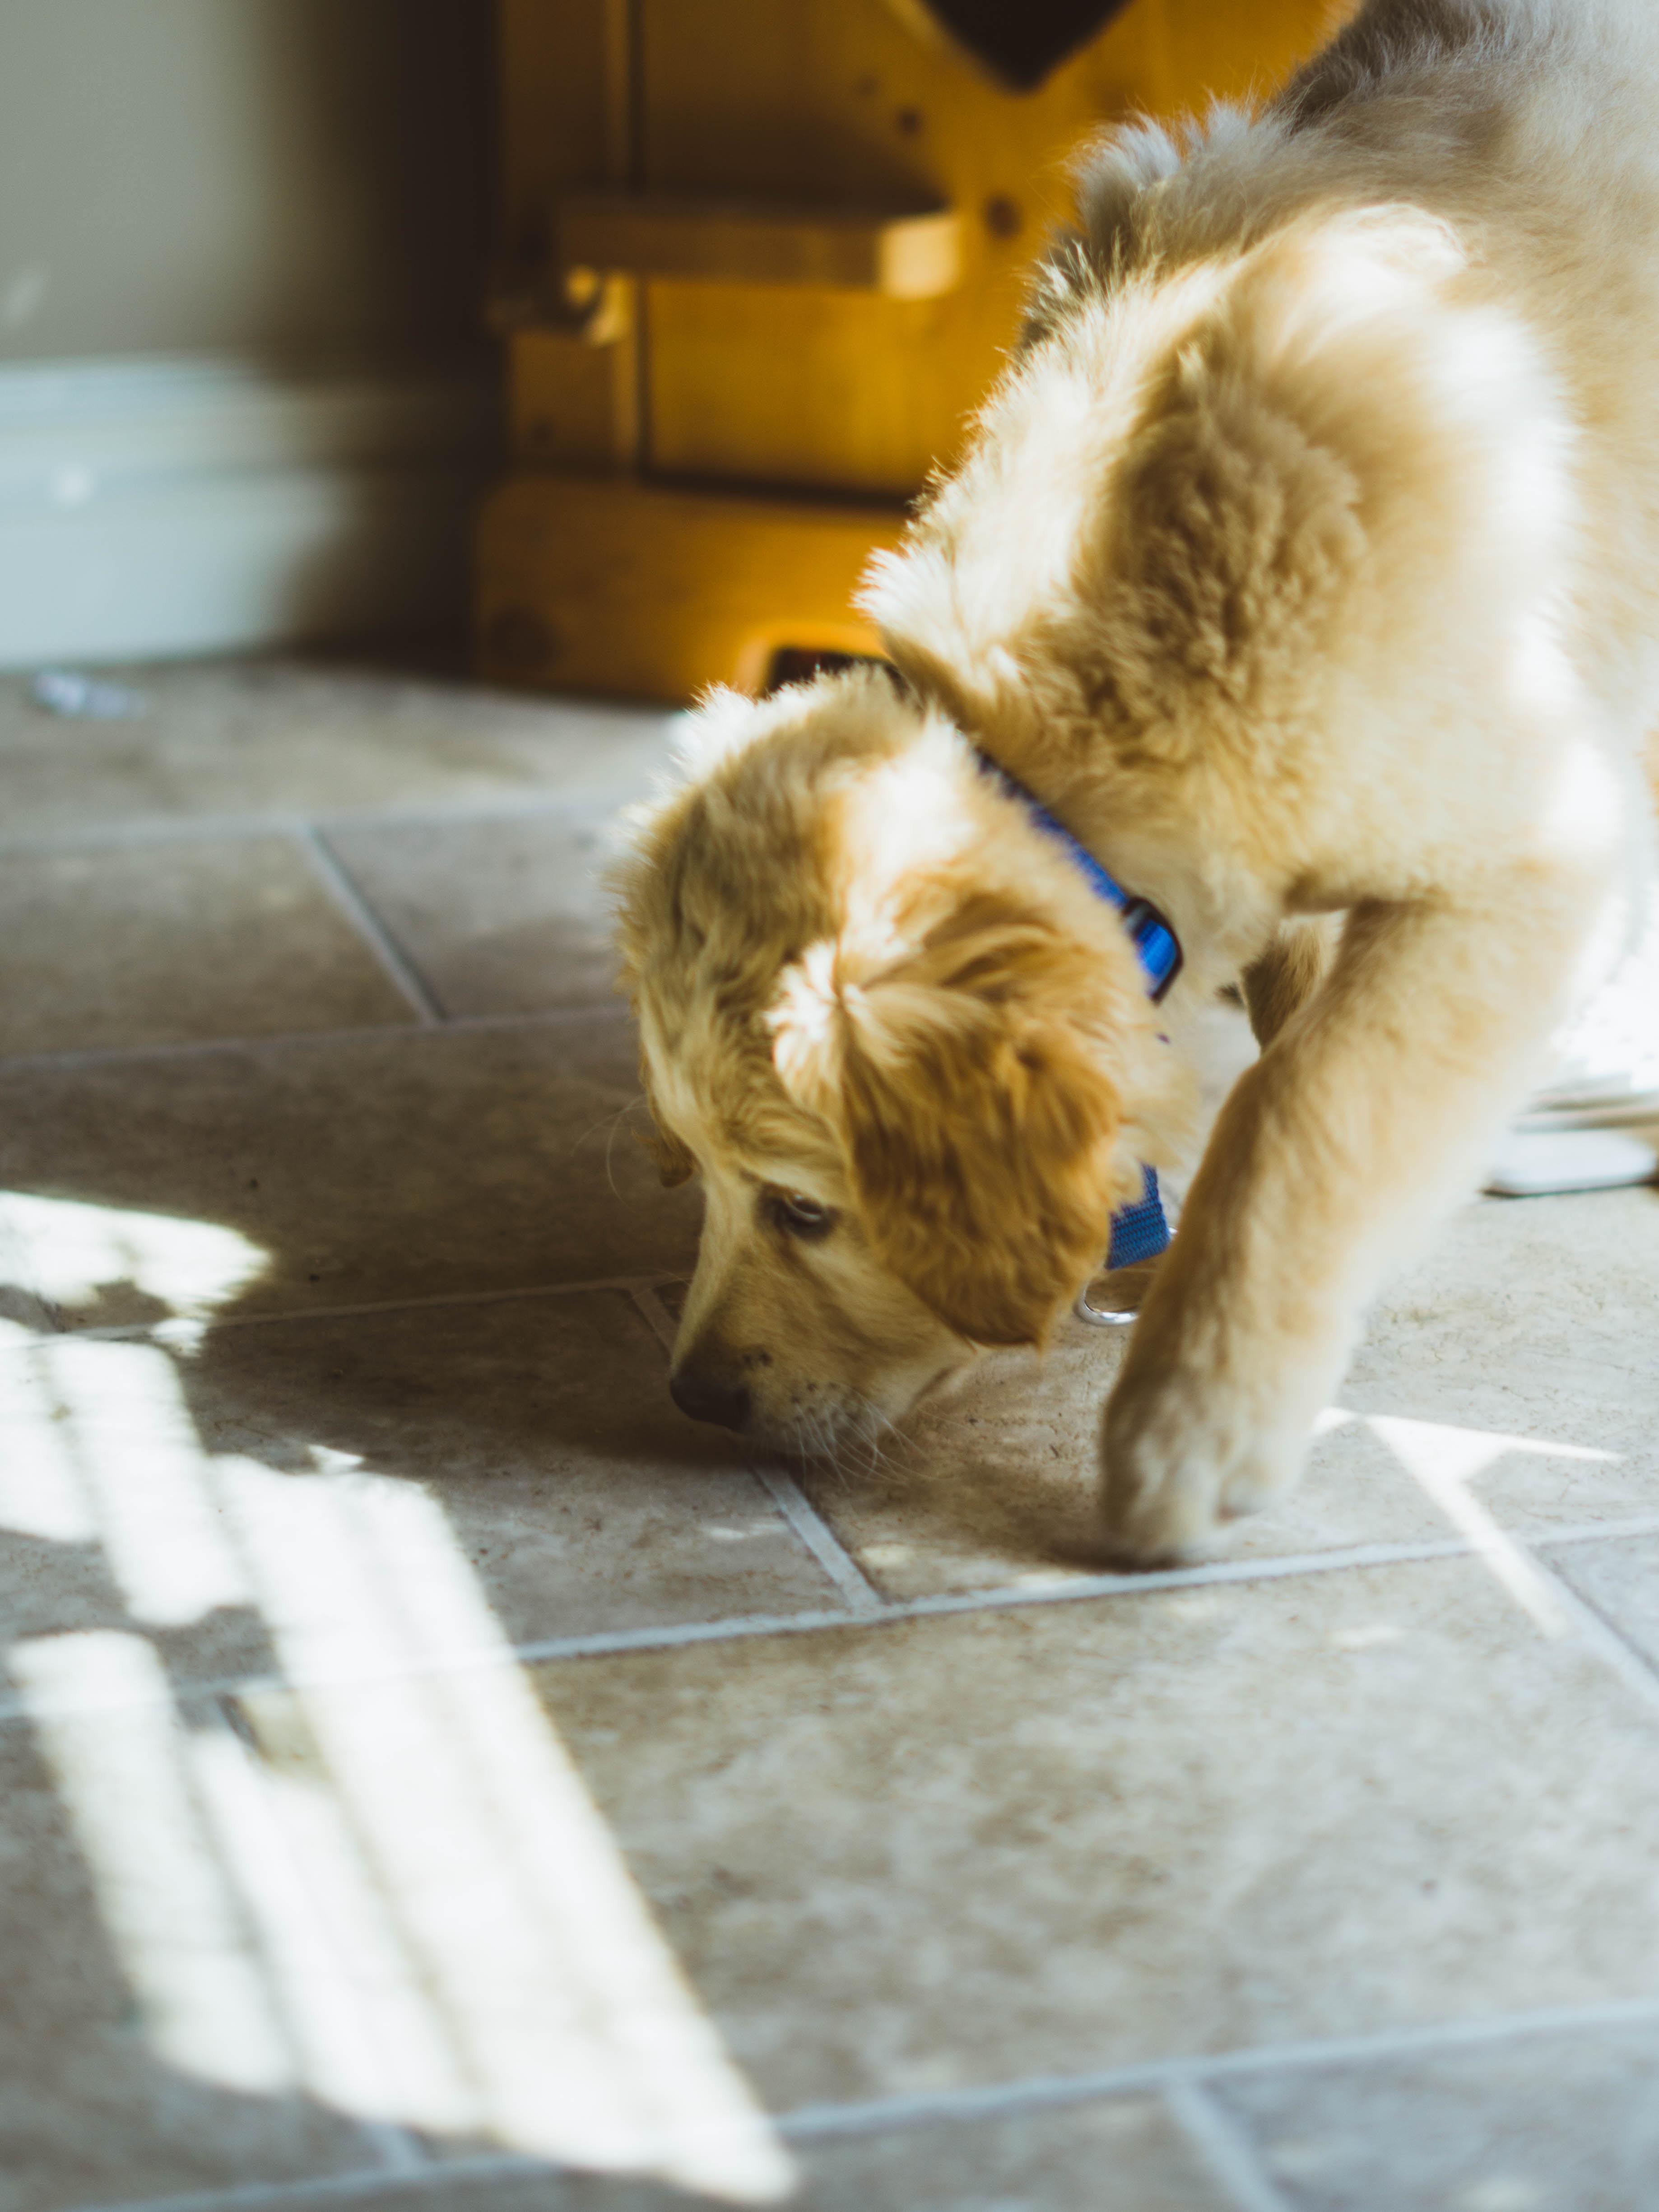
{"left": 330, "top": 809, "right": 617, "bottom": 1015}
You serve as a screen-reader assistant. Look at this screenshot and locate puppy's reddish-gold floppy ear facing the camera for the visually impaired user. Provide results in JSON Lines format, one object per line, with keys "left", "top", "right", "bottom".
{"left": 772, "top": 918, "right": 1124, "bottom": 1345}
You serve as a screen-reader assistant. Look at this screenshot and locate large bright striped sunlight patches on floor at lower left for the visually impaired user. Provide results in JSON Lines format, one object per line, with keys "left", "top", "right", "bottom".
{"left": 0, "top": 1201, "right": 794, "bottom": 2203}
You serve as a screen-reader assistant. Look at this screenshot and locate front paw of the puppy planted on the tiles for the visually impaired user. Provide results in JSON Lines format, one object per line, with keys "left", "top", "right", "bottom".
{"left": 1101, "top": 1371, "right": 1301, "bottom": 1566}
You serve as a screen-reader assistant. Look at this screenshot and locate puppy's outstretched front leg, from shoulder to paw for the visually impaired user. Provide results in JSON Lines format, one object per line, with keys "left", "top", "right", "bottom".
{"left": 1104, "top": 869, "right": 1595, "bottom": 1561}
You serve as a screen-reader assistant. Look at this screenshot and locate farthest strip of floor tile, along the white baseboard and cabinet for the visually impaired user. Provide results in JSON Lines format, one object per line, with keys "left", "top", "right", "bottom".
{"left": 0, "top": 657, "right": 668, "bottom": 838}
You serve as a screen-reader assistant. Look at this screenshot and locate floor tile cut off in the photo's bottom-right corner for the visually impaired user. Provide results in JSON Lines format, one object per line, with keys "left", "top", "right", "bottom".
{"left": 1221, "top": 2028, "right": 1659, "bottom": 2212}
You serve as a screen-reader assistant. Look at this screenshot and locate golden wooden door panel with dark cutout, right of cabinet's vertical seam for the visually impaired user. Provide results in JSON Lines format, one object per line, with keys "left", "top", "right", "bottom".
{"left": 635, "top": 0, "right": 1325, "bottom": 493}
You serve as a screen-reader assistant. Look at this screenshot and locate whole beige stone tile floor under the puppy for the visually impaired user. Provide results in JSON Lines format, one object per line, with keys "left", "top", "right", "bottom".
{"left": 0, "top": 661, "right": 1659, "bottom": 2212}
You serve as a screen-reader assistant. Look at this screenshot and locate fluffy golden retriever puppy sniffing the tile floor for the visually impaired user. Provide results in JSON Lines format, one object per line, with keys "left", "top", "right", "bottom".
{"left": 622, "top": 0, "right": 1659, "bottom": 1560}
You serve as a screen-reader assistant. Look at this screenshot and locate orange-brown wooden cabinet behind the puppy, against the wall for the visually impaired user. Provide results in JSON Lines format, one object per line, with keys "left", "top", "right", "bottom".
{"left": 478, "top": 0, "right": 1329, "bottom": 699}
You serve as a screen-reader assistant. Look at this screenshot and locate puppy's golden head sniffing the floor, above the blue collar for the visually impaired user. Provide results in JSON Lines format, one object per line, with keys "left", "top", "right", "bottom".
{"left": 622, "top": 675, "right": 1159, "bottom": 1449}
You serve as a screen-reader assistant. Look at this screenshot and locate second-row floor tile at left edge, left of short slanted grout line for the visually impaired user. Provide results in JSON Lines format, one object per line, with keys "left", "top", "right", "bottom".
{"left": 0, "top": 836, "right": 411, "bottom": 1053}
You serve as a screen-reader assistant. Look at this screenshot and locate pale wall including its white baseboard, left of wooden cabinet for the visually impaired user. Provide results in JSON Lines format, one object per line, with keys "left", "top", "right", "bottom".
{"left": 0, "top": 0, "right": 496, "bottom": 664}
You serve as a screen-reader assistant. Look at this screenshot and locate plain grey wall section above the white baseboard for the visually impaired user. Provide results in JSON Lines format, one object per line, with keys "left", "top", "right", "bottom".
{"left": 0, "top": 0, "right": 491, "bottom": 361}
